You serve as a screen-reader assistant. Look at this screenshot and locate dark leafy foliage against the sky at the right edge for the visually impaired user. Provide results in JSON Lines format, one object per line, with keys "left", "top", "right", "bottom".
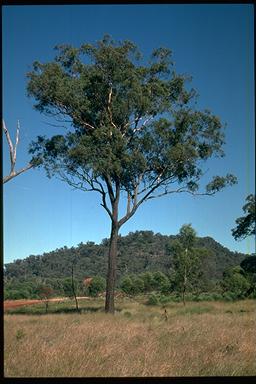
{"left": 231, "top": 194, "right": 256, "bottom": 240}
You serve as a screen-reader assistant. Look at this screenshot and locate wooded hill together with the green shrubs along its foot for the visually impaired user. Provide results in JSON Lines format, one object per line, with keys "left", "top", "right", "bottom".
{"left": 4, "top": 231, "right": 255, "bottom": 299}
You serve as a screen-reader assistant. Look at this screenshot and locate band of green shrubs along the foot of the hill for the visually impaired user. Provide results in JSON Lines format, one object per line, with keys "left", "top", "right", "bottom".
{"left": 4, "top": 266, "right": 256, "bottom": 304}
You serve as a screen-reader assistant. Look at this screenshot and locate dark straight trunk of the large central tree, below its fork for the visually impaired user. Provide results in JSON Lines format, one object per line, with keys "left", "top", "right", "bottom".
{"left": 105, "top": 220, "right": 119, "bottom": 314}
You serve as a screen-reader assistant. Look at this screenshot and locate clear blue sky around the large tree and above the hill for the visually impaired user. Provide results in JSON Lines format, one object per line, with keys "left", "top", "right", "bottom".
{"left": 3, "top": 4, "right": 255, "bottom": 263}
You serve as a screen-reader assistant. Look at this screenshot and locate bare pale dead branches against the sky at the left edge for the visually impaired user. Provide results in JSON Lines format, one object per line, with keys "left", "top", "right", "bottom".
{"left": 3, "top": 120, "right": 33, "bottom": 184}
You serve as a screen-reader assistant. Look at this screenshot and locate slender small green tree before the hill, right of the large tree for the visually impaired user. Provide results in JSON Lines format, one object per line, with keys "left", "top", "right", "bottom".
{"left": 169, "top": 224, "right": 206, "bottom": 305}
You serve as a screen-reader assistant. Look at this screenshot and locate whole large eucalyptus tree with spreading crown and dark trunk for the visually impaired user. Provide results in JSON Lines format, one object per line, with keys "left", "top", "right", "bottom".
{"left": 27, "top": 36, "right": 236, "bottom": 313}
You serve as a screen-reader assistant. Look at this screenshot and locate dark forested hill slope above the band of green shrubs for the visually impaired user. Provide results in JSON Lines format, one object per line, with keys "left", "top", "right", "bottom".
{"left": 5, "top": 231, "right": 247, "bottom": 280}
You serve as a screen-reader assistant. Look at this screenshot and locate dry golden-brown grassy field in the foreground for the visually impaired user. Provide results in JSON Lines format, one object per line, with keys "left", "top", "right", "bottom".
{"left": 4, "top": 299, "right": 256, "bottom": 377}
